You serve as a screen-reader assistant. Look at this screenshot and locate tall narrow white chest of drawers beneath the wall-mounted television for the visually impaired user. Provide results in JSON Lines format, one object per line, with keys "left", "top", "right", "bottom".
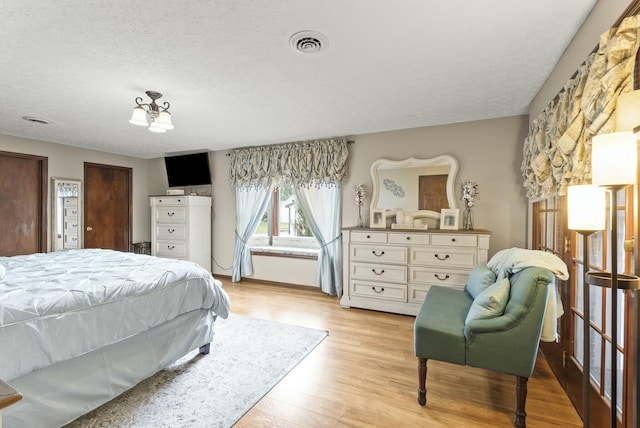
{"left": 149, "top": 195, "right": 211, "bottom": 272}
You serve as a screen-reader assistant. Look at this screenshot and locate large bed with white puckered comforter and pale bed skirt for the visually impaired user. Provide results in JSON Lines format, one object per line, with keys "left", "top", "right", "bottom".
{"left": 0, "top": 249, "right": 229, "bottom": 428}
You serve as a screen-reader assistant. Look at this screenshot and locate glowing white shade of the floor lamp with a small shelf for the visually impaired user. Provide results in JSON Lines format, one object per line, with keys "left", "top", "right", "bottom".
{"left": 591, "top": 132, "right": 638, "bottom": 186}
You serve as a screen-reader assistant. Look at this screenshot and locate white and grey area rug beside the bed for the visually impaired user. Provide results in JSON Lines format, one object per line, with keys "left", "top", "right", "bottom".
{"left": 67, "top": 314, "right": 327, "bottom": 428}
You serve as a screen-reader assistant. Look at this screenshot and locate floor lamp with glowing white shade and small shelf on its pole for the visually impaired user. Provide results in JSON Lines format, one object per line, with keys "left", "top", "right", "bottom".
{"left": 587, "top": 132, "right": 640, "bottom": 427}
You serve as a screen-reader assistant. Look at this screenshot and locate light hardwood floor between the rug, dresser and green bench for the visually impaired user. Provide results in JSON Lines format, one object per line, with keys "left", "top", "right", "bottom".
{"left": 220, "top": 277, "right": 582, "bottom": 428}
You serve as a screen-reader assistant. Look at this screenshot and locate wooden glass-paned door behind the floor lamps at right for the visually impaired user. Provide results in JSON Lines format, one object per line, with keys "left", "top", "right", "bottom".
{"left": 567, "top": 188, "right": 637, "bottom": 427}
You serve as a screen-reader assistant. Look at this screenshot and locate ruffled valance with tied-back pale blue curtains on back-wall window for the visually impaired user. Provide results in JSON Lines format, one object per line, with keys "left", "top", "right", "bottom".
{"left": 229, "top": 138, "right": 349, "bottom": 296}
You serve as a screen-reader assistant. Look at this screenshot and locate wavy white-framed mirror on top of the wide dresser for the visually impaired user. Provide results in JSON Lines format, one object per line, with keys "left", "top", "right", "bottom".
{"left": 371, "top": 155, "right": 458, "bottom": 227}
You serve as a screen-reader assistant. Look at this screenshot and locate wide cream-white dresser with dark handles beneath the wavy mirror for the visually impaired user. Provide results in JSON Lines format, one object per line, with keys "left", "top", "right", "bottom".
{"left": 340, "top": 228, "right": 491, "bottom": 315}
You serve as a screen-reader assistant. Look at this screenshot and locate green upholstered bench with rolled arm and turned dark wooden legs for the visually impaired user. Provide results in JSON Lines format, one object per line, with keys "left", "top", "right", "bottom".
{"left": 414, "top": 264, "right": 554, "bottom": 427}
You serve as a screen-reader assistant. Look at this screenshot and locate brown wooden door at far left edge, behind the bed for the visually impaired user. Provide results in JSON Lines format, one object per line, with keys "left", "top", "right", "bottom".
{"left": 0, "top": 152, "right": 47, "bottom": 256}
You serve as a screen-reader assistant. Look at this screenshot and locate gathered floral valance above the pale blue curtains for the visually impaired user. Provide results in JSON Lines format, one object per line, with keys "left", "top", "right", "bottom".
{"left": 229, "top": 138, "right": 349, "bottom": 188}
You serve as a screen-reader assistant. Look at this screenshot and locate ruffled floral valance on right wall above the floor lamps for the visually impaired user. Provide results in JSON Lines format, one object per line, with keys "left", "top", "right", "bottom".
{"left": 521, "top": 15, "right": 640, "bottom": 198}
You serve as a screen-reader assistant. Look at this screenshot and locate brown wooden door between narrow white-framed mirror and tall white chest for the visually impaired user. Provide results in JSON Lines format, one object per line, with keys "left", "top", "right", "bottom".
{"left": 84, "top": 162, "right": 133, "bottom": 251}
